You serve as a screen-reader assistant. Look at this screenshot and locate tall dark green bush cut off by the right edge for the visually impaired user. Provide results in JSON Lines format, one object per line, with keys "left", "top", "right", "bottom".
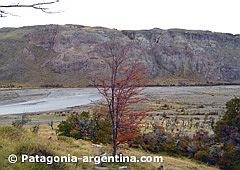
{"left": 214, "top": 98, "right": 240, "bottom": 170}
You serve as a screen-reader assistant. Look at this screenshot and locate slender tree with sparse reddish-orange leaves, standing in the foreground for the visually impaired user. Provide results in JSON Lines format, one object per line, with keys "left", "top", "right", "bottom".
{"left": 94, "top": 39, "right": 146, "bottom": 155}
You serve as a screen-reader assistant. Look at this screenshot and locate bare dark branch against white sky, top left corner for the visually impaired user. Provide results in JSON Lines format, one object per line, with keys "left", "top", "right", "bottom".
{"left": 0, "top": 0, "right": 59, "bottom": 17}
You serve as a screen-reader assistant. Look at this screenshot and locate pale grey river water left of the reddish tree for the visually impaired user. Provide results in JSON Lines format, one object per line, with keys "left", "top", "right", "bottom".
{"left": 0, "top": 88, "right": 101, "bottom": 115}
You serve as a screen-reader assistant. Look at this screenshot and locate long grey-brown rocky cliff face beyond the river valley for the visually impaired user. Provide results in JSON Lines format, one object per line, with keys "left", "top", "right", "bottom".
{"left": 0, "top": 25, "right": 240, "bottom": 86}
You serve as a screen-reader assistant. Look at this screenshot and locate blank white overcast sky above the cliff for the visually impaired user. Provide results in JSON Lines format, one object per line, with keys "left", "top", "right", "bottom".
{"left": 0, "top": 0, "right": 240, "bottom": 34}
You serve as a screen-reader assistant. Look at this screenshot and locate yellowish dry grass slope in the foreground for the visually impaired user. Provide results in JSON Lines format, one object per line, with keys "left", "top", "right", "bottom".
{"left": 0, "top": 124, "right": 217, "bottom": 170}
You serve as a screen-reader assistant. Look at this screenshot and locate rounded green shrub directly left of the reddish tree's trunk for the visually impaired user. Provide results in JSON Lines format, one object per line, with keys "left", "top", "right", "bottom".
{"left": 57, "top": 112, "right": 112, "bottom": 143}
